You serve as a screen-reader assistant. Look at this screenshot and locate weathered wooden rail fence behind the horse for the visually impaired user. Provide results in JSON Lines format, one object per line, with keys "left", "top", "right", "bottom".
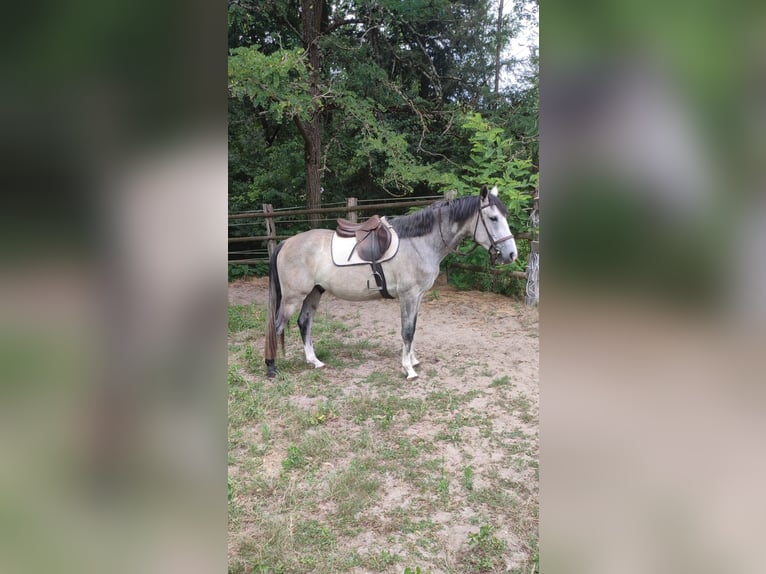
{"left": 229, "top": 196, "right": 539, "bottom": 302}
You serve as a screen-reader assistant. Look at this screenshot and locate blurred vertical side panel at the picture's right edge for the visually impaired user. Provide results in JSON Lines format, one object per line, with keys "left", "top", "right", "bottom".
{"left": 540, "top": 1, "right": 766, "bottom": 572}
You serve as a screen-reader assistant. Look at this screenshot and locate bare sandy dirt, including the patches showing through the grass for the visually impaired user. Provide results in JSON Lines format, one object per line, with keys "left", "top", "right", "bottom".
{"left": 229, "top": 277, "right": 539, "bottom": 572}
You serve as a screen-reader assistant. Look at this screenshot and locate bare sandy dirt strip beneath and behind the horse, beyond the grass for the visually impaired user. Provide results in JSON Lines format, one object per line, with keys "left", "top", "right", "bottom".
{"left": 229, "top": 275, "right": 540, "bottom": 398}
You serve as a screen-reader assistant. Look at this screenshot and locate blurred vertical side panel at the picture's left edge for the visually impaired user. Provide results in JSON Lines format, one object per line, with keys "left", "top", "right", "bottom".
{"left": 0, "top": 0, "right": 227, "bottom": 572}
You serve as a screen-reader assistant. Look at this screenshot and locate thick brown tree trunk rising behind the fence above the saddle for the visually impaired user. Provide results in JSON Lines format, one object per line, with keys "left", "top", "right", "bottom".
{"left": 296, "top": 0, "right": 324, "bottom": 227}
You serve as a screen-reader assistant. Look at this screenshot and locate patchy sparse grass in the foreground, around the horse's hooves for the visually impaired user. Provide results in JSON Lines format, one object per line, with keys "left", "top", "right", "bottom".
{"left": 227, "top": 304, "right": 538, "bottom": 574}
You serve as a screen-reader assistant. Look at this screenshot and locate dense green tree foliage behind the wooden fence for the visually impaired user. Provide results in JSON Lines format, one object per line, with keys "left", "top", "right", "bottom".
{"left": 228, "top": 0, "right": 538, "bottom": 294}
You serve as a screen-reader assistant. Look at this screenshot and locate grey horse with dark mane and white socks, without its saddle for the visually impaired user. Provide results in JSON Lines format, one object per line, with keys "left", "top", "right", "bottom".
{"left": 264, "top": 185, "right": 518, "bottom": 380}
